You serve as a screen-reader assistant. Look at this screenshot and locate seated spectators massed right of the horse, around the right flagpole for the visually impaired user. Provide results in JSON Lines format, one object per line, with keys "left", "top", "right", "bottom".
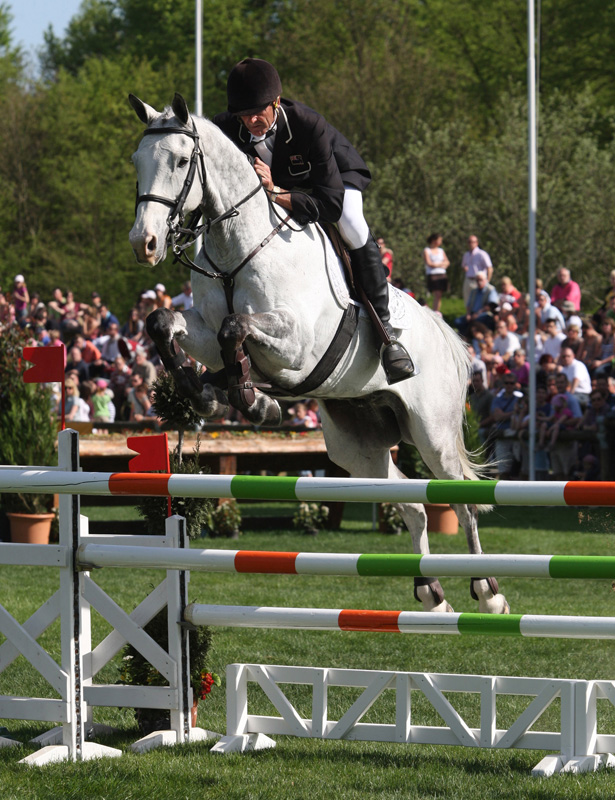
{"left": 455, "top": 248, "right": 615, "bottom": 480}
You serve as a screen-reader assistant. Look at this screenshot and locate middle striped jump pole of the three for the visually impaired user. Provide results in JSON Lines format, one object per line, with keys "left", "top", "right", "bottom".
{"left": 77, "top": 544, "right": 615, "bottom": 580}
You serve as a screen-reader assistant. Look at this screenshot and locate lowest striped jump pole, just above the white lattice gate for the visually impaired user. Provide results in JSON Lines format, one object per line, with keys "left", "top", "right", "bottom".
{"left": 184, "top": 603, "right": 615, "bottom": 639}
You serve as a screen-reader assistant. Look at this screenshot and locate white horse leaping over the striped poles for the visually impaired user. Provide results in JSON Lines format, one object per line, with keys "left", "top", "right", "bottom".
{"left": 130, "top": 95, "right": 508, "bottom": 613}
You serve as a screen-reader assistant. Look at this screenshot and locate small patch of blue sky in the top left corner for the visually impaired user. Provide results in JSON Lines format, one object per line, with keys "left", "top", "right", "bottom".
{"left": 5, "top": 0, "right": 81, "bottom": 53}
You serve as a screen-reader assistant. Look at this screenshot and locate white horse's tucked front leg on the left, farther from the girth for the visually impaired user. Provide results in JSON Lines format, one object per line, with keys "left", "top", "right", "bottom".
{"left": 146, "top": 308, "right": 229, "bottom": 419}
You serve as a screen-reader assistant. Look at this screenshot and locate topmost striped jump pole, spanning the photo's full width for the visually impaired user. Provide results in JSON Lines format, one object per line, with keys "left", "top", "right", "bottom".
{"left": 0, "top": 468, "right": 615, "bottom": 506}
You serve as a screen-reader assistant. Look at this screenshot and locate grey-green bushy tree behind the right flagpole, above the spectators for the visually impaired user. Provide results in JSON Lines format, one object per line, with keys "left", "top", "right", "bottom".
{"left": 366, "top": 92, "right": 615, "bottom": 307}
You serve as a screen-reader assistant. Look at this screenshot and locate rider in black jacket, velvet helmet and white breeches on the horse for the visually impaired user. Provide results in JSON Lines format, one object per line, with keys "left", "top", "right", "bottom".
{"left": 213, "top": 58, "right": 415, "bottom": 384}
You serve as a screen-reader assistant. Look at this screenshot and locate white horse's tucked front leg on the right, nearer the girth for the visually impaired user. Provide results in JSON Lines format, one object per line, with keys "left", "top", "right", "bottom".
{"left": 218, "top": 311, "right": 300, "bottom": 425}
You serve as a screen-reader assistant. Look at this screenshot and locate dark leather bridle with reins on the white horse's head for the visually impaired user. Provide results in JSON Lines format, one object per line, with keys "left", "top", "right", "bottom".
{"left": 135, "top": 119, "right": 290, "bottom": 313}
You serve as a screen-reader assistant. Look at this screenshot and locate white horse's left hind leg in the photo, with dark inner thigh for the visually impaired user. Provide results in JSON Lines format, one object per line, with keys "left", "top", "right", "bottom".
{"left": 320, "top": 400, "right": 453, "bottom": 611}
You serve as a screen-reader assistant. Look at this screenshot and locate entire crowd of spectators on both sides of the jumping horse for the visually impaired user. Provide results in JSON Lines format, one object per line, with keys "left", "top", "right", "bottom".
{"left": 0, "top": 233, "right": 615, "bottom": 462}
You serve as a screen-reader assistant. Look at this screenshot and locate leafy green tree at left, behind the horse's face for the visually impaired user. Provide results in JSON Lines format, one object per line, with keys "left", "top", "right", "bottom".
{"left": 0, "top": 56, "right": 195, "bottom": 315}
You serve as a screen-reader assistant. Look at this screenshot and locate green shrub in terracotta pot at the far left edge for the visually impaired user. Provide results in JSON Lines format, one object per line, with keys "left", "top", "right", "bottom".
{"left": 0, "top": 325, "right": 57, "bottom": 543}
